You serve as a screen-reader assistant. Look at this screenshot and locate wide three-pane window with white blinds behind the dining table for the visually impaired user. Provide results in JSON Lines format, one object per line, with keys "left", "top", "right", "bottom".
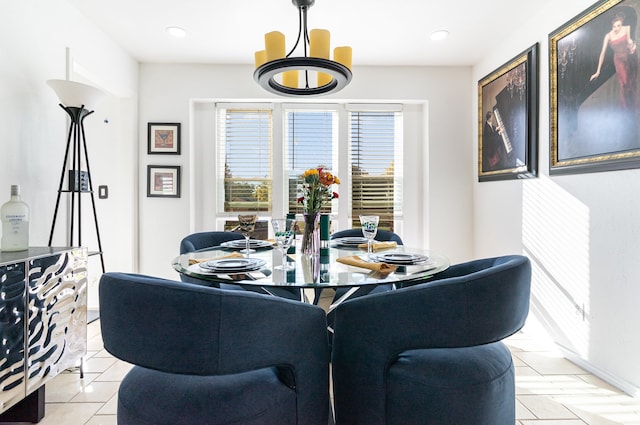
{"left": 215, "top": 103, "right": 403, "bottom": 234}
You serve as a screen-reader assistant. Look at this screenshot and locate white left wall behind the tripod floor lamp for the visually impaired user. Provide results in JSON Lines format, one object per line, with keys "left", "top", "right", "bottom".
{"left": 0, "top": 0, "right": 138, "bottom": 307}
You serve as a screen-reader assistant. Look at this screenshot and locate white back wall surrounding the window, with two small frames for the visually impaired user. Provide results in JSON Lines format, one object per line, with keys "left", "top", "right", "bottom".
{"left": 139, "top": 64, "right": 473, "bottom": 279}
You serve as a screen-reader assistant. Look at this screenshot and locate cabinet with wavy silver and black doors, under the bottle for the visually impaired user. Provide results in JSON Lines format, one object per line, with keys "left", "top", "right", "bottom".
{"left": 0, "top": 247, "right": 87, "bottom": 422}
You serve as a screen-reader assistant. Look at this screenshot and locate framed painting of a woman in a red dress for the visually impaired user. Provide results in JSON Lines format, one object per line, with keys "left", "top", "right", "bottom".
{"left": 549, "top": 0, "right": 640, "bottom": 174}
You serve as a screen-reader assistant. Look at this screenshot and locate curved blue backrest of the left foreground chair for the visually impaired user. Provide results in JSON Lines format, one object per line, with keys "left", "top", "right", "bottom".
{"left": 99, "top": 273, "right": 329, "bottom": 424}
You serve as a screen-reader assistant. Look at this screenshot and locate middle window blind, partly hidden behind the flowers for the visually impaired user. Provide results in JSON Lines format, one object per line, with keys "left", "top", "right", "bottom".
{"left": 285, "top": 109, "right": 337, "bottom": 213}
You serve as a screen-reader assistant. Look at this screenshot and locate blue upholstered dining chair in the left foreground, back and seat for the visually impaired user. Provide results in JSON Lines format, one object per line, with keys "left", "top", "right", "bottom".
{"left": 99, "top": 273, "right": 329, "bottom": 425}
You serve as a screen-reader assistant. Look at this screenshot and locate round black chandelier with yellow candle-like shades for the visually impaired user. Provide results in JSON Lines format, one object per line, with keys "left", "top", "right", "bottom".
{"left": 253, "top": 0, "right": 352, "bottom": 97}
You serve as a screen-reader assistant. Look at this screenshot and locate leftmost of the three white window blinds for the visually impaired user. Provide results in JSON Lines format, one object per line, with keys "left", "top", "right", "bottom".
{"left": 217, "top": 108, "right": 273, "bottom": 212}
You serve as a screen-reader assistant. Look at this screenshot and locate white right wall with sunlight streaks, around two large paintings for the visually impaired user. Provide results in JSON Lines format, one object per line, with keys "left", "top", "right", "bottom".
{"left": 469, "top": 0, "right": 640, "bottom": 395}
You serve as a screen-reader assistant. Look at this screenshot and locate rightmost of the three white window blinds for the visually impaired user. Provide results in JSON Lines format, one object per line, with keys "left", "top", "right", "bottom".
{"left": 349, "top": 110, "right": 402, "bottom": 231}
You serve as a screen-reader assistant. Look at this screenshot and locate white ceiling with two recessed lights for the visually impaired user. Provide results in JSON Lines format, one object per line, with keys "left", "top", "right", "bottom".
{"left": 68, "top": 0, "right": 552, "bottom": 67}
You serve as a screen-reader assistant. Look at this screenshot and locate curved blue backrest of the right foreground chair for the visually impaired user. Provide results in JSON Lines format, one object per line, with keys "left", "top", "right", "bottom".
{"left": 332, "top": 255, "right": 531, "bottom": 424}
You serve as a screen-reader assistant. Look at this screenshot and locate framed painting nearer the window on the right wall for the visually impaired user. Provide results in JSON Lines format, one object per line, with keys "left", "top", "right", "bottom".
{"left": 478, "top": 43, "right": 539, "bottom": 182}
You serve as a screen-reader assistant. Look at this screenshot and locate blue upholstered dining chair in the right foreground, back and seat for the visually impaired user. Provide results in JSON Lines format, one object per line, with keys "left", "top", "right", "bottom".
{"left": 332, "top": 255, "right": 531, "bottom": 425}
